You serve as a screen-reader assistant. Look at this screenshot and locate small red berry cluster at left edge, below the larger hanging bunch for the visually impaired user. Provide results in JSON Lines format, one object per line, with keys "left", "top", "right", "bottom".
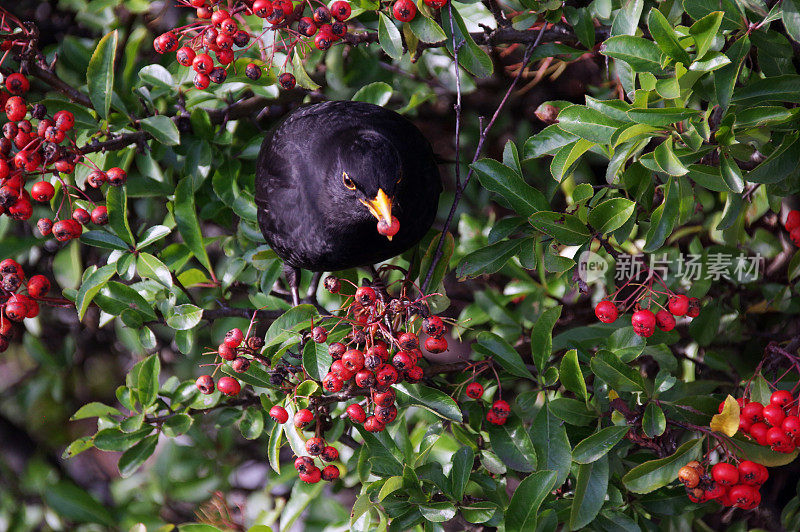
{"left": 0, "top": 259, "right": 50, "bottom": 353}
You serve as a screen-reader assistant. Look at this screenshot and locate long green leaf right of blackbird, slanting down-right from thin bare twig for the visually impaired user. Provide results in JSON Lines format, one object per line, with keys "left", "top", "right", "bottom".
{"left": 471, "top": 159, "right": 549, "bottom": 216}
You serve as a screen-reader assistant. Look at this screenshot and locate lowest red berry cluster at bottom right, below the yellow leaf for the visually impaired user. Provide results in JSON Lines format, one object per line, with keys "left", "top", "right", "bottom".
{"left": 678, "top": 460, "right": 769, "bottom": 510}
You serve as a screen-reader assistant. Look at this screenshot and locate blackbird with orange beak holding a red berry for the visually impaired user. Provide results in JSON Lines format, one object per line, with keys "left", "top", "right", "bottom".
{"left": 255, "top": 101, "right": 442, "bottom": 305}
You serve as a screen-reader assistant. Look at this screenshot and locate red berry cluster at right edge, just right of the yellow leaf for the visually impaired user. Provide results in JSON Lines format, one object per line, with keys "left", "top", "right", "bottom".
{"left": 732, "top": 390, "right": 800, "bottom": 453}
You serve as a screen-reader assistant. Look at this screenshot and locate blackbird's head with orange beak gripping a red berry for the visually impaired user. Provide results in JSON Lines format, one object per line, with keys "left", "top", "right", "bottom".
{"left": 334, "top": 130, "right": 403, "bottom": 240}
